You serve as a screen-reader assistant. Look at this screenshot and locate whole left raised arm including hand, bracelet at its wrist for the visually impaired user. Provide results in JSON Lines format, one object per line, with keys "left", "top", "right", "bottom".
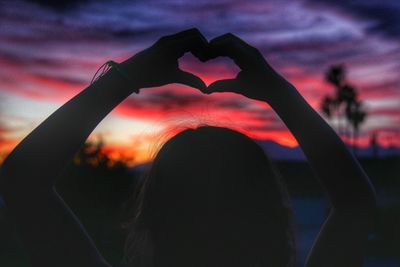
{"left": 0, "top": 29, "right": 207, "bottom": 267}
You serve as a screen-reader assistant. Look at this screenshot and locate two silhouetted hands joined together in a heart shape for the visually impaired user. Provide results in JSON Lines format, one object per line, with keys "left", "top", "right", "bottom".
{"left": 121, "top": 29, "right": 287, "bottom": 101}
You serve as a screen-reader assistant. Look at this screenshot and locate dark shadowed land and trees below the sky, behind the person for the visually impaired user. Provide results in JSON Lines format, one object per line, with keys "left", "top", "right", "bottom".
{"left": 0, "top": 142, "right": 400, "bottom": 267}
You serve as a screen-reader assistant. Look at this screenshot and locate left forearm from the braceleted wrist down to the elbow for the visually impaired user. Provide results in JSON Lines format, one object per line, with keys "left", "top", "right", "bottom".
{"left": 0, "top": 65, "right": 136, "bottom": 195}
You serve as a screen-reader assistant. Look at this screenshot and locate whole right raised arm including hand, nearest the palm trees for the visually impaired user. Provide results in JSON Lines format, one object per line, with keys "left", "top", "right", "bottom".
{"left": 208, "top": 34, "right": 375, "bottom": 267}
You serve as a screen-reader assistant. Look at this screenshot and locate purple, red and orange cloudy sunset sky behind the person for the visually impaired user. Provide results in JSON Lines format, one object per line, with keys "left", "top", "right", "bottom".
{"left": 0, "top": 0, "right": 400, "bottom": 163}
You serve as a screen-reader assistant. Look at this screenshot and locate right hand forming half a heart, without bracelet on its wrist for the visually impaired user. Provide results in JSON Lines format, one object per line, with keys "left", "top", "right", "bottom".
{"left": 207, "top": 33, "right": 289, "bottom": 102}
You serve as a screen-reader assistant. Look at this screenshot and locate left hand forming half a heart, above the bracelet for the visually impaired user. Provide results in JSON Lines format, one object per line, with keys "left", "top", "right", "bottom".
{"left": 121, "top": 28, "right": 209, "bottom": 92}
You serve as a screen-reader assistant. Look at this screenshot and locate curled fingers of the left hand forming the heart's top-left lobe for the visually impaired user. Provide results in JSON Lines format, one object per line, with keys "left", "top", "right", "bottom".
{"left": 160, "top": 28, "right": 210, "bottom": 62}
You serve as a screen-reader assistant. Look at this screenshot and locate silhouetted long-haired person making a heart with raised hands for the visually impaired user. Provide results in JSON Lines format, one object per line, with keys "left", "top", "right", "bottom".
{"left": 0, "top": 29, "right": 375, "bottom": 267}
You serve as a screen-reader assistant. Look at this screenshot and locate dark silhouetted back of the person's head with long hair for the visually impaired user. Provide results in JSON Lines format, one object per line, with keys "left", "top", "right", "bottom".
{"left": 125, "top": 126, "right": 294, "bottom": 267}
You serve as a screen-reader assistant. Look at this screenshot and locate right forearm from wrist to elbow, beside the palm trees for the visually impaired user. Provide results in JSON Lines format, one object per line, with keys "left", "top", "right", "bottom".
{"left": 269, "top": 83, "right": 375, "bottom": 211}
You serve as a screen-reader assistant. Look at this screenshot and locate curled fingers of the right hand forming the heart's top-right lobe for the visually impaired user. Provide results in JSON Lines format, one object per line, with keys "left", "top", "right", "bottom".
{"left": 210, "top": 33, "right": 256, "bottom": 69}
